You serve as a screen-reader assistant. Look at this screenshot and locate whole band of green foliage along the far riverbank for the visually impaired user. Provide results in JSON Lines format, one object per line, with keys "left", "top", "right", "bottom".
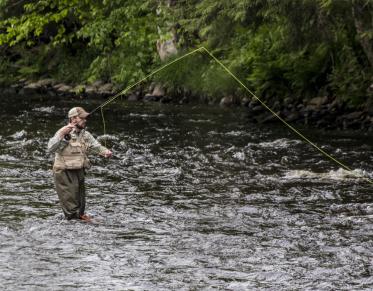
{"left": 0, "top": 0, "right": 373, "bottom": 106}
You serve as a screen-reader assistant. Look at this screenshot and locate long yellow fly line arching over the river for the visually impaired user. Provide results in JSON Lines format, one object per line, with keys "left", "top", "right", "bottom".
{"left": 90, "top": 47, "right": 373, "bottom": 184}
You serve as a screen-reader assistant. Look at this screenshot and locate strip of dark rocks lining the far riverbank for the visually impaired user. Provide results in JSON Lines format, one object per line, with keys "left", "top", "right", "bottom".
{"left": 1, "top": 79, "right": 373, "bottom": 132}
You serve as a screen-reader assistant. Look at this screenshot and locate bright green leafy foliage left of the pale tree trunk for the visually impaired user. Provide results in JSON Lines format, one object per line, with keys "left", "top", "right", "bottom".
{"left": 0, "top": 0, "right": 158, "bottom": 85}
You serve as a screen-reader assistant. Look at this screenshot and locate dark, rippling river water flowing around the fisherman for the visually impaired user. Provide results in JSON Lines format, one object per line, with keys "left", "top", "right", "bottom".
{"left": 0, "top": 98, "right": 373, "bottom": 290}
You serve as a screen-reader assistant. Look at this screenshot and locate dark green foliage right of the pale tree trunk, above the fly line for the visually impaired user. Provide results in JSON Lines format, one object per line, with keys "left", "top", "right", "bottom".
{"left": 169, "top": 0, "right": 373, "bottom": 105}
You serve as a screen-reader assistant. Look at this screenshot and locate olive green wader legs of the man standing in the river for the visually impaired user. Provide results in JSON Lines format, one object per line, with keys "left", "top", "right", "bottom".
{"left": 53, "top": 169, "right": 85, "bottom": 219}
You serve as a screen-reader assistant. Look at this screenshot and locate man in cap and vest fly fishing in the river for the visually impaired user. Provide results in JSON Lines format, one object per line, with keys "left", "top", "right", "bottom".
{"left": 48, "top": 107, "right": 112, "bottom": 221}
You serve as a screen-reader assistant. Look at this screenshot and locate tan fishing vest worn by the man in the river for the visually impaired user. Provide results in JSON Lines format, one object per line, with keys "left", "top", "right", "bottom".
{"left": 53, "top": 133, "right": 90, "bottom": 171}
